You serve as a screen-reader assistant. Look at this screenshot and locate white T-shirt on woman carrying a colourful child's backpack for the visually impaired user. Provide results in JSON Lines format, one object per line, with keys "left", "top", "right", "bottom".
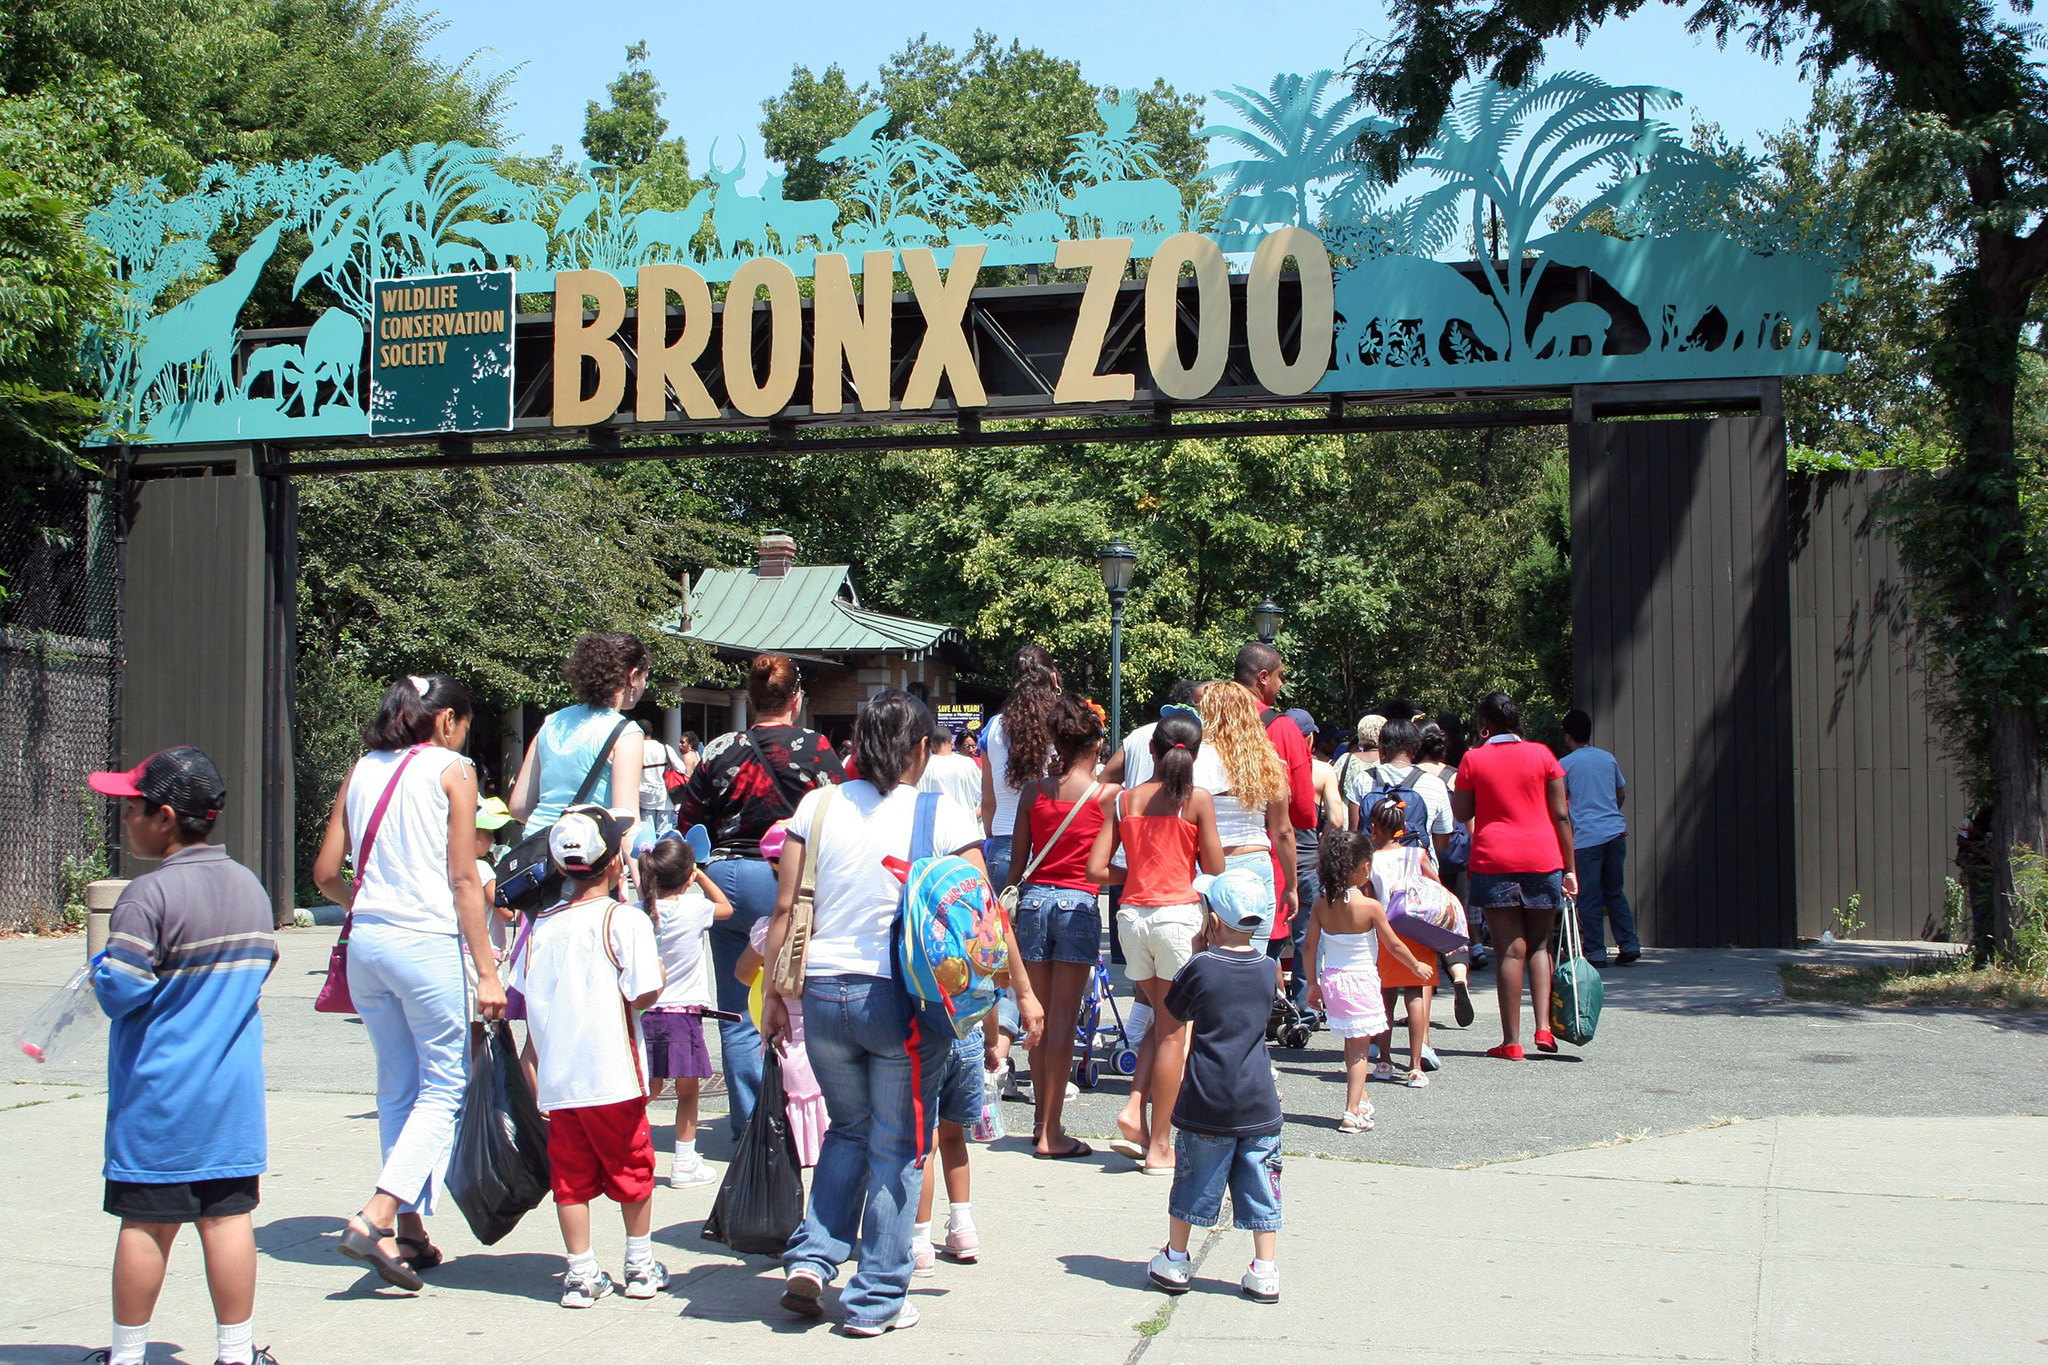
{"left": 788, "top": 778, "right": 983, "bottom": 976}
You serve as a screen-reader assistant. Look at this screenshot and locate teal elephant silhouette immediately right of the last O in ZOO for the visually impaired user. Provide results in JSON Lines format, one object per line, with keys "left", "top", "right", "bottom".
{"left": 1337, "top": 256, "right": 1509, "bottom": 368}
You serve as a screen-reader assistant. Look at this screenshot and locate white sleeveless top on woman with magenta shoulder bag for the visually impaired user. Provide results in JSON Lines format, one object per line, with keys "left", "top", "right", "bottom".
{"left": 344, "top": 745, "right": 469, "bottom": 935}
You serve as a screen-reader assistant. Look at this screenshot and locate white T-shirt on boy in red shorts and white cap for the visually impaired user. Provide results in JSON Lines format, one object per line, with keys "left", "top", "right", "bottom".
{"left": 510, "top": 900, "right": 662, "bottom": 1111}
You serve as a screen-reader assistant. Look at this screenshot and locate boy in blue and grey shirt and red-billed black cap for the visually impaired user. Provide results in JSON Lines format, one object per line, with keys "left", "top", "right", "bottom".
{"left": 88, "top": 749, "right": 276, "bottom": 1365}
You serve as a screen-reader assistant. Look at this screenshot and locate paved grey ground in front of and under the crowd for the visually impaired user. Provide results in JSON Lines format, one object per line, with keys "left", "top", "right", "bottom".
{"left": 0, "top": 933, "right": 2048, "bottom": 1365}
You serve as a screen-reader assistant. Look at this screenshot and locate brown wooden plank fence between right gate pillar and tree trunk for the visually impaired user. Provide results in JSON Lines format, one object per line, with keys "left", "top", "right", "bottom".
{"left": 1792, "top": 471, "right": 1968, "bottom": 939}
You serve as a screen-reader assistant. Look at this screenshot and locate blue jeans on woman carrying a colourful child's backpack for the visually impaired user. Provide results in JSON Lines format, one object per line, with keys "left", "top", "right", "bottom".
{"left": 782, "top": 976, "right": 950, "bottom": 1324}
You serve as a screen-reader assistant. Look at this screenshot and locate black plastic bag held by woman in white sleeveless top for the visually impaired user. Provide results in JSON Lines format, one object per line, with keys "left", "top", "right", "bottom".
{"left": 449, "top": 1019, "right": 551, "bottom": 1246}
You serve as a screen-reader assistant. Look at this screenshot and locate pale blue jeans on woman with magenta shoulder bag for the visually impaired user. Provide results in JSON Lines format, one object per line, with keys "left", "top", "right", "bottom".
{"left": 348, "top": 921, "right": 469, "bottom": 1214}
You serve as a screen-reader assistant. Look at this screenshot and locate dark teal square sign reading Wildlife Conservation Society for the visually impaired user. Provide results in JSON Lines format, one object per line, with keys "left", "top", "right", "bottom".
{"left": 371, "top": 270, "right": 516, "bottom": 436}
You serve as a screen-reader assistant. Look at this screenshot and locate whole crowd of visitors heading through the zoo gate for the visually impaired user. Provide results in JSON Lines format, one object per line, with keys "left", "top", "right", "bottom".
{"left": 83, "top": 634, "right": 1640, "bottom": 1365}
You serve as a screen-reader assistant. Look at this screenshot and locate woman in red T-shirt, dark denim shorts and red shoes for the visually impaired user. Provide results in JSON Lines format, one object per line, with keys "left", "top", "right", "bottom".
{"left": 1450, "top": 692, "right": 1579, "bottom": 1062}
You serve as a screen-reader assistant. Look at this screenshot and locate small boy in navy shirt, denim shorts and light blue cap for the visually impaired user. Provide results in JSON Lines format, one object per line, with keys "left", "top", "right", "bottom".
{"left": 1149, "top": 868, "right": 1280, "bottom": 1304}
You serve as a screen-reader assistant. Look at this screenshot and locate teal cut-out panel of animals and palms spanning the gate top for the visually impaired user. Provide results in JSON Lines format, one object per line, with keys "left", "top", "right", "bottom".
{"left": 86, "top": 72, "right": 1849, "bottom": 444}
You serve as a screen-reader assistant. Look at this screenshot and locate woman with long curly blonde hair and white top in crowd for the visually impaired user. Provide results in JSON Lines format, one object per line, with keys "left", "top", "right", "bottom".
{"left": 1194, "top": 681, "right": 1300, "bottom": 923}
